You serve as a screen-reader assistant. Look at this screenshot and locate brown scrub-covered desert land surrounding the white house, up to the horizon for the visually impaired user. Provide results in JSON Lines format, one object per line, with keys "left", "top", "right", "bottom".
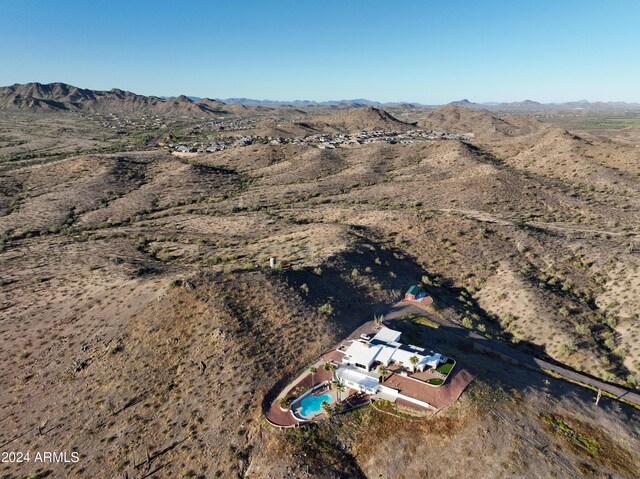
{"left": 0, "top": 80, "right": 640, "bottom": 479}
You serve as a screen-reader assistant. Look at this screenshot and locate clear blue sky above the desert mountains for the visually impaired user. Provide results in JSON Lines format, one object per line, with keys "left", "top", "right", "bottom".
{"left": 0, "top": 0, "right": 640, "bottom": 103}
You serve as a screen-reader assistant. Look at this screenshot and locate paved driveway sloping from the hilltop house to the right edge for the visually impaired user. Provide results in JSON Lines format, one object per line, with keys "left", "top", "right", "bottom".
{"left": 383, "top": 301, "right": 640, "bottom": 406}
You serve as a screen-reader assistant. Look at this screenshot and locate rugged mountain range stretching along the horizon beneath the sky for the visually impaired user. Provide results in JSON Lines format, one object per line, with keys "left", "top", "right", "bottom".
{"left": 0, "top": 83, "right": 640, "bottom": 118}
